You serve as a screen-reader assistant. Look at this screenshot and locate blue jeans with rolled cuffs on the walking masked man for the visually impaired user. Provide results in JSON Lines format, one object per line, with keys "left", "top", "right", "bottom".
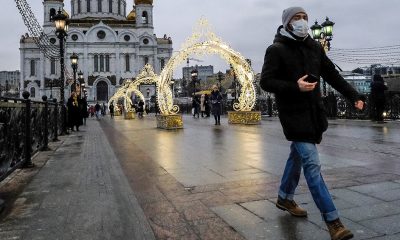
{"left": 278, "top": 142, "right": 339, "bottom": 221}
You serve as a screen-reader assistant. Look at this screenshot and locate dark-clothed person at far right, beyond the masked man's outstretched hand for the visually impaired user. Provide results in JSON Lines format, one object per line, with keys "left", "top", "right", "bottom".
{"left": 370, "top": 75, "right": 387, "bottom": 123}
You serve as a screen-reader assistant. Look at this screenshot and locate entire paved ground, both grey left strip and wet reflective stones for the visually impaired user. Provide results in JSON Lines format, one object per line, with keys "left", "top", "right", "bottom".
{"left": 0, "top": 116, "right": 400, "bottom": 240}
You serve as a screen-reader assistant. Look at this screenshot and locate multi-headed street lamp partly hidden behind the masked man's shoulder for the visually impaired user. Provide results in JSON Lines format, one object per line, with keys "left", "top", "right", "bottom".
{"left": 310, "top": 17, "right": 335, "bottom": 96}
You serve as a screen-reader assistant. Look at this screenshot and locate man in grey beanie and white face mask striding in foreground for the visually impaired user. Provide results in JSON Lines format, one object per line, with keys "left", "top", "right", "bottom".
{"left": 260, "top": 7, "right": 364, "bottom": 240}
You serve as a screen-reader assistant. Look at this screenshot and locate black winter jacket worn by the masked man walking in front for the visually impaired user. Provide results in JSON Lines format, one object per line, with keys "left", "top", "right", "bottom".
{"left": 260, "top": 26, "right": 360, "bottom": 143}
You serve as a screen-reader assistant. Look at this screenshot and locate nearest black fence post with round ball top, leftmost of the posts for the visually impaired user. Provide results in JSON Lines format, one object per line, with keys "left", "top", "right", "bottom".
{"left": 22, "top": 91, "right": 34, "bottom": 168}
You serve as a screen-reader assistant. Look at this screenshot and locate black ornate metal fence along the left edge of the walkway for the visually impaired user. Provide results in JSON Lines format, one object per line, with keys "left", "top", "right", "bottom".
{"left": 0, "top": 92, "right": 61, "bottom": 181}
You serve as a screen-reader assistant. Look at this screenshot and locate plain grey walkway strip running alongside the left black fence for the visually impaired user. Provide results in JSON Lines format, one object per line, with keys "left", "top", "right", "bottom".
{"left": 0, "top": 121, "right": 155, "bottom": 240}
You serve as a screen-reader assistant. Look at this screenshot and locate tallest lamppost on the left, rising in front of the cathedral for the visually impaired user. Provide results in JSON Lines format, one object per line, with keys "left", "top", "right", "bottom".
{"left": 53, "top": 9, "right": 68, "bottom": 134}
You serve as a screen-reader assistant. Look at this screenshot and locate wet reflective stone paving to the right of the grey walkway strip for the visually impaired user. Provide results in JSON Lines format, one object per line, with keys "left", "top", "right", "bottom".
{"left": 97, "top": 116, "right": 400, "bottom": 240}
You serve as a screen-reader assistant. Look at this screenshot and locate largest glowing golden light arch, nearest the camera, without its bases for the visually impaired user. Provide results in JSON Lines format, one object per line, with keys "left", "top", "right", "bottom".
{"left": 157, "top": 18, "right": 256, "bottom": 115}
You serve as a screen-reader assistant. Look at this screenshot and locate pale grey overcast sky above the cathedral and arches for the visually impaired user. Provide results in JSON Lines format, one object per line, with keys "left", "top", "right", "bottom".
{"left": 0, "top": 0, "right": 400, "bottom": 75}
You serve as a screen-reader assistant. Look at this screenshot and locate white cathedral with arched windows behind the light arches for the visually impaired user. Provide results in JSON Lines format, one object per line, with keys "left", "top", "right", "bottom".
{"left": 20, "top": 0, "right": 172, "bottom": 101}
